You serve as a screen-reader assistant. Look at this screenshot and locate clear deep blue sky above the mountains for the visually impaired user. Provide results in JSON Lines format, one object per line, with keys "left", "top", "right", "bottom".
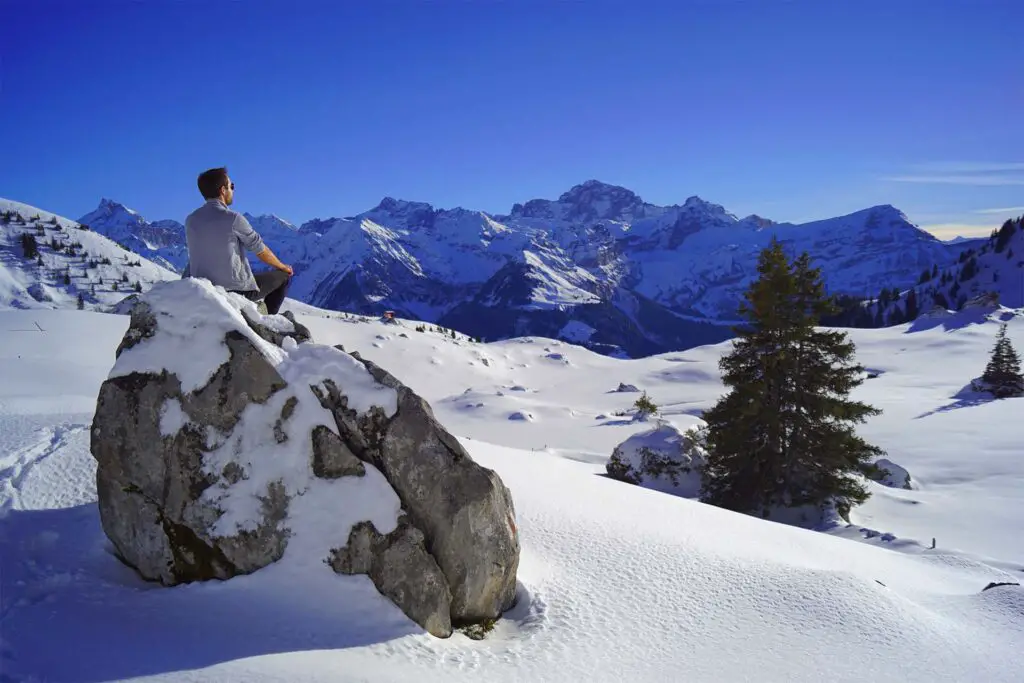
{"left": 0, "top": 0, "right": 1024, "bottom": 237}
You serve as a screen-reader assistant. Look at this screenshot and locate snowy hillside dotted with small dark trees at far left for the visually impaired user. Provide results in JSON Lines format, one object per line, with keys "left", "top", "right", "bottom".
{"left": 0, "top": 199, "right": 178, "bottom": 309}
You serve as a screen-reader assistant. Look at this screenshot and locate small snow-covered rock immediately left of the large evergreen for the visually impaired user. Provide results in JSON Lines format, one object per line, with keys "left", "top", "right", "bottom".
{"left": 605, "top": 420, "right": 707, "bottom": 498}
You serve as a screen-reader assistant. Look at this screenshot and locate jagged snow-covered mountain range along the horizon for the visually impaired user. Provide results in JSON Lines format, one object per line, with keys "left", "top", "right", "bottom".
{"left": 0, "top": 180, "right": 980, "bottom": 356}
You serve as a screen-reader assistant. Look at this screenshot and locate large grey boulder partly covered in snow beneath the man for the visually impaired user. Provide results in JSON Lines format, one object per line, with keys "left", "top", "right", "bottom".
{"left": 91, "top": 279, "right": 519, "bottom": 637}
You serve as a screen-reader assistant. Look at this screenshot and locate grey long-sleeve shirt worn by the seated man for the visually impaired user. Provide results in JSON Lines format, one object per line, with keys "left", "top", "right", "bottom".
{"left": 183, "top": 200, "right": 266, "bottom": 292}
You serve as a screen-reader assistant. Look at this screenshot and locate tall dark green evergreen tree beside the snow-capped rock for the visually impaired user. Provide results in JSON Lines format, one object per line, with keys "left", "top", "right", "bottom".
{"left": 702, "top": 241, "right": 882, "bottom": 516}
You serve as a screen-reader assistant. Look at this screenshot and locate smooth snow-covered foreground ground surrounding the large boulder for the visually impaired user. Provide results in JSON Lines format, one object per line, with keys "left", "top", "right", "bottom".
{"left": 0, "top": 302, "right": 1024, "bottom": 683}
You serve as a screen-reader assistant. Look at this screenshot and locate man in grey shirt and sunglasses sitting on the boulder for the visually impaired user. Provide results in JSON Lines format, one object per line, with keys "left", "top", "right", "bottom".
{"left": 182, "top": 168, "right": 293, "bottom": 314}
